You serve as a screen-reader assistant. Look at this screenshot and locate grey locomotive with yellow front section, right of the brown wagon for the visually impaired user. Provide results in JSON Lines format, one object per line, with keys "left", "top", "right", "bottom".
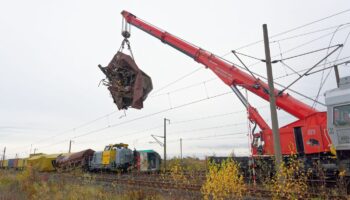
{"left": 89, "top": 143, "right": 134, "bottom": 171}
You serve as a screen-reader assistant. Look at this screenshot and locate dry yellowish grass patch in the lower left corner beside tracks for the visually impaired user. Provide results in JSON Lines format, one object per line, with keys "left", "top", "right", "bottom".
{"left": 0, "top": 169, "right": 159, "bottom": 200}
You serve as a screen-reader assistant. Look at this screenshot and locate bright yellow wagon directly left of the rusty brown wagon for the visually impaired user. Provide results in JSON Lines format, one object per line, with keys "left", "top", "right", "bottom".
{"left": 27, "top": 154, "right": 60, "bottom": 172}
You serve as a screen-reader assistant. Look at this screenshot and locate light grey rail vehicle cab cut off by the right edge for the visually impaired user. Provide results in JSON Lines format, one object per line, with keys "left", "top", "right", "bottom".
{"left": 325, "top": 76, "right": 350, "bottom": 175}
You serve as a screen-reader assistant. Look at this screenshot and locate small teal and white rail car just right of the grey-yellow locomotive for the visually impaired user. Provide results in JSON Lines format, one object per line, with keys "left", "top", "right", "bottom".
{"left": 134, "top": 150, "right": 161, "bottom": 172}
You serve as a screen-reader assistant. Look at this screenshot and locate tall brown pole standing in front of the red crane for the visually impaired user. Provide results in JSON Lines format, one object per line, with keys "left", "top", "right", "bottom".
{"left": 263, "top": 24, "right": 282, "bottom": 170}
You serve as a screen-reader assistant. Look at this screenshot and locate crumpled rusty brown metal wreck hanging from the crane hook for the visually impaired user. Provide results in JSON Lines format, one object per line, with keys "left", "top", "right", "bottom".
{"left": 98, "top": 51, "right": 153, "bottom": 110}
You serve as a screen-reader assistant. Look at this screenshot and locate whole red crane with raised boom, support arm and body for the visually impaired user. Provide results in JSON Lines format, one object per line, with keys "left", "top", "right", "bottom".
{"left": 121, "top": 11, "right": 332, "bottom": 161}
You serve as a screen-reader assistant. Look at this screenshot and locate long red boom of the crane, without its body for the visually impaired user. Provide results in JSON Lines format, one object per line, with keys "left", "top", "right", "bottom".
{"left": 121, "top": 11, "right": 318, "bottom": 119}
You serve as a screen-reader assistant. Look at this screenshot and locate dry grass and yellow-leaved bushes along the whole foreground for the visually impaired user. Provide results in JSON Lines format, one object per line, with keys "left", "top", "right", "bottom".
{"left": 0, "top": 156, "right": 346, "bottom": 200}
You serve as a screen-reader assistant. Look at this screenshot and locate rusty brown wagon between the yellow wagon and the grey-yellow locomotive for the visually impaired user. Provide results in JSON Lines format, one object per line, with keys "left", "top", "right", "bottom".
{"left": 55, "top": 149, "right": 95, "bottom": 171}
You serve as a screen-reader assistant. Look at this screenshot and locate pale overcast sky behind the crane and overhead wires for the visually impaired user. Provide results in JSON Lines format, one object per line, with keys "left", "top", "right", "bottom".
{"left": 0, "top": 0, "right": 350, "bottom": 157}
